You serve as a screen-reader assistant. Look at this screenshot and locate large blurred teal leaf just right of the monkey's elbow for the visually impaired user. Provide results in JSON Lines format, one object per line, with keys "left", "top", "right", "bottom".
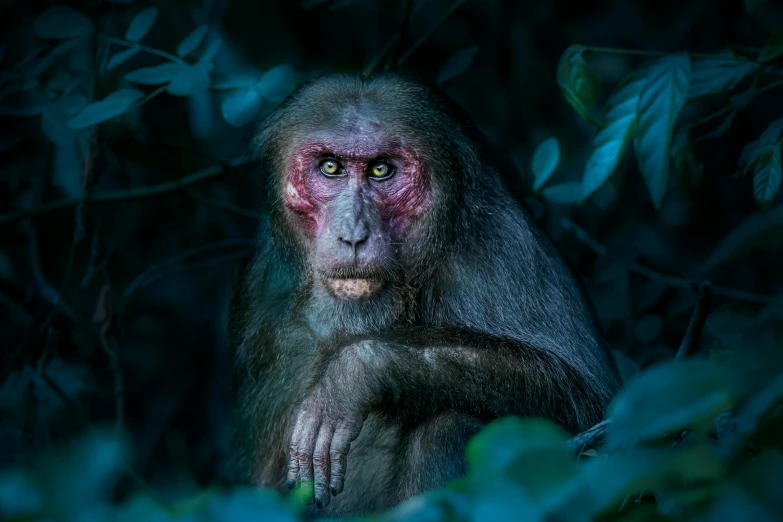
{"left": 606, "top": 359, "right": 731, "bottom": 449}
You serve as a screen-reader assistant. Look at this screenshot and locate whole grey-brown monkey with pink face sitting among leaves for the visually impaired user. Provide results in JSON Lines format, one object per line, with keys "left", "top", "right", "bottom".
{"left": 231, "top": 73, "right": 619, "bottom": 516}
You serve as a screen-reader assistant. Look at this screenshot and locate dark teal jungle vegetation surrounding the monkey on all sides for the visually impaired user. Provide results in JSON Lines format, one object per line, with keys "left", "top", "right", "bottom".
{"left": 0, "top": 0, "right": 783, "bottom": 521}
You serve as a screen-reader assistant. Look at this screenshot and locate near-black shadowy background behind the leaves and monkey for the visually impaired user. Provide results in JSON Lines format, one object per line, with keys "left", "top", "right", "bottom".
{"left": 0, "top": 0, "right": 783, "bottom": 508}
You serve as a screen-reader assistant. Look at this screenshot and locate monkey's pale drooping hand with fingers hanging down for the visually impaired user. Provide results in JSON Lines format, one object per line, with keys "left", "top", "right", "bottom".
{"left": 288, "top": 341, "right": 380, "bottom": 509}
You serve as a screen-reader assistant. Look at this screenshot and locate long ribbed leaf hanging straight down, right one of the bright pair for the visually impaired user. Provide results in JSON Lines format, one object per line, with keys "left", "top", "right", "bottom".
{"left": 634, "top": 54, "right": 691, "bottom": 209}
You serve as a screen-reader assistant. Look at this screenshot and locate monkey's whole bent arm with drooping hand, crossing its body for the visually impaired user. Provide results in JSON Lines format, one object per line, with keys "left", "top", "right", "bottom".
{"left": 288, "top": 328, "right": 608, "bottom": 507}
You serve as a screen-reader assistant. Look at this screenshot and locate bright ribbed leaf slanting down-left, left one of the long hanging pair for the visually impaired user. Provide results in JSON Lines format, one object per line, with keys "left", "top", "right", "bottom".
{"left": 581, "top": 71, "right": 647, "bottom": 201}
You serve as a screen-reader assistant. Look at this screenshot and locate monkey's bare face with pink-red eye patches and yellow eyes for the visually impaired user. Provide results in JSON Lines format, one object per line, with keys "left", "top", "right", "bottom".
{"left": 283, "top": 116, "right": 430, "bottom": 300}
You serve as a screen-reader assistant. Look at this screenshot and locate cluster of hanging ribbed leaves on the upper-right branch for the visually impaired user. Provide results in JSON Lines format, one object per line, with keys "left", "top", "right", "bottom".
{"left": 558, "top": 41, "right": 783, "bottom": 208}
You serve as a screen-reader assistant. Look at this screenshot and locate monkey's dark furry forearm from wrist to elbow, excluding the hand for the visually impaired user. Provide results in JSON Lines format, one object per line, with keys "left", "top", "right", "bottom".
{"left": 336, "top": 330, "right": 607, "bottom": 432}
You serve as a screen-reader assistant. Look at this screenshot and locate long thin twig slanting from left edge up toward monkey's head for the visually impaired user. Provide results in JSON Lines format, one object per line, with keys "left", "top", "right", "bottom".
{"left": 0, "top": 158, "right": 245, "bottom": 224}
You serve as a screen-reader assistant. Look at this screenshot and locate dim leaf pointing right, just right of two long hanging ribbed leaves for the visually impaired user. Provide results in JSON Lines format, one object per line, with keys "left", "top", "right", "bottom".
{"left": 688, "top": 51, "right": 761, "bottom": 100}
